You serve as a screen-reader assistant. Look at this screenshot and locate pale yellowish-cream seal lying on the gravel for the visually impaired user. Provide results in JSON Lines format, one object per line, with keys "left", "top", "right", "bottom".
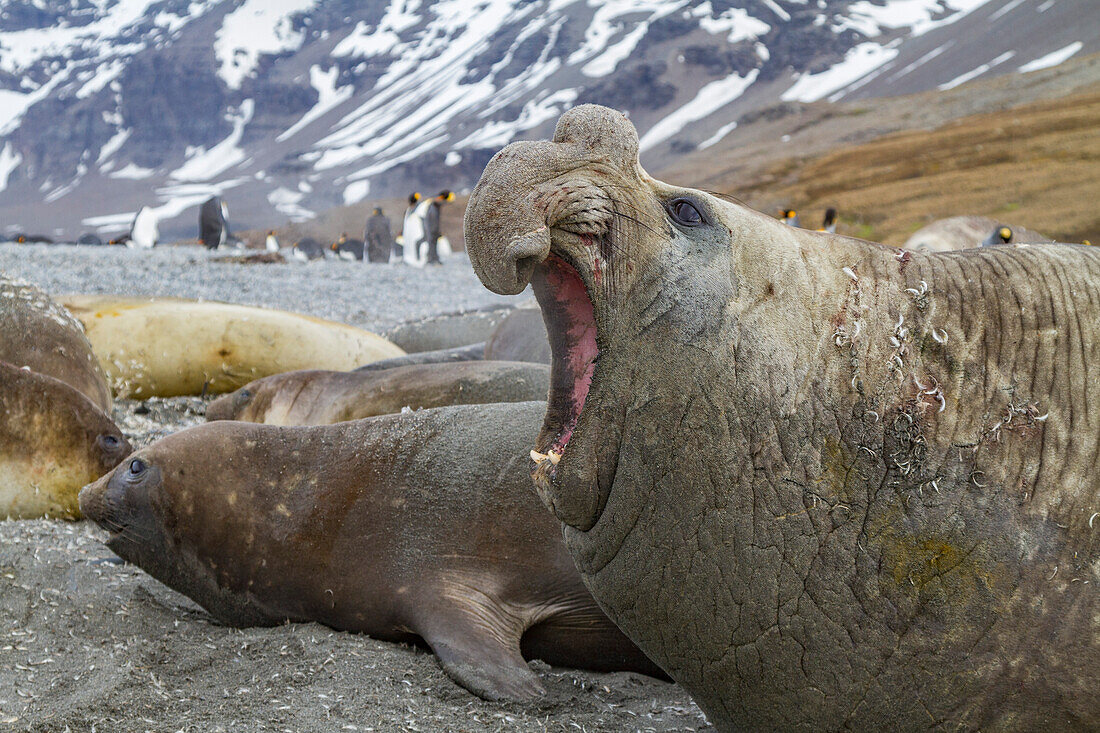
{"left": 58, "top": 295, "right": 405, "bottom": 398}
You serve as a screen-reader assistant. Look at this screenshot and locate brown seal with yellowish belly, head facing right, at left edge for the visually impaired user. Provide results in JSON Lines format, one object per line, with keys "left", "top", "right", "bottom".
{"left": 0, "top": 362, "right": 131, "bottom": 519}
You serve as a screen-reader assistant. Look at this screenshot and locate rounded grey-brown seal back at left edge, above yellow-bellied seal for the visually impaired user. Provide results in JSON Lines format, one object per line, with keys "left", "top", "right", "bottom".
{"left": 0, "top": 276, "right": 111, "bottom": 412}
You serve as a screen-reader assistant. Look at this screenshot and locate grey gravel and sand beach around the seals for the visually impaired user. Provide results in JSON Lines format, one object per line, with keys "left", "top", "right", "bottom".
{"left": 0, "top": 244, "right": 707, "bottom": 733}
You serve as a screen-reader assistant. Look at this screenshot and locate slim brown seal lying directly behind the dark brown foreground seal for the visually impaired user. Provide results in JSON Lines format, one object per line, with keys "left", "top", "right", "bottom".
{"left": 207, "top": 361, "right": 550, "bottom": 425}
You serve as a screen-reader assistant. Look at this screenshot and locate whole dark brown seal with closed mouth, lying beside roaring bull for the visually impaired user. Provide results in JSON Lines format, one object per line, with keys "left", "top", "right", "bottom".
{"left": 80, "top": 403, "right": 660, "bottom": 700}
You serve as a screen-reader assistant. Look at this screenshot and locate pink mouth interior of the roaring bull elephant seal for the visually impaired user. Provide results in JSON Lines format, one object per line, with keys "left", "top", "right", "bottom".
{"left": 536, "top": 255, "right": 600, "bottom": 453}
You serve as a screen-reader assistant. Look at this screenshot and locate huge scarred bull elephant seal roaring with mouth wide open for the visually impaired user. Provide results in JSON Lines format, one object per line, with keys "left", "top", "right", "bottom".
{"left": 465, "top": 106, "right": 1100, "bottom": 730}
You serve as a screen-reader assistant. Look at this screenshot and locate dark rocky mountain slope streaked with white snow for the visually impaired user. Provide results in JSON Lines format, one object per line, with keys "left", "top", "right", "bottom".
{"left": 0, "top": 0, "right": 1100, "bottom": 237}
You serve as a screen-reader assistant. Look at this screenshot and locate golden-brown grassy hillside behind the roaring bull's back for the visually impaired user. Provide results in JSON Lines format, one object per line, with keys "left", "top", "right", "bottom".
{"left": 722, "top": 88, "right": 1100, "bottom": 245}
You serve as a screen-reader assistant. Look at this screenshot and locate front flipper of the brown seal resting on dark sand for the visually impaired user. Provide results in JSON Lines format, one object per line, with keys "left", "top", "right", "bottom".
{"left": 417, "top": 598, "right": 546, "bottom": 702}
